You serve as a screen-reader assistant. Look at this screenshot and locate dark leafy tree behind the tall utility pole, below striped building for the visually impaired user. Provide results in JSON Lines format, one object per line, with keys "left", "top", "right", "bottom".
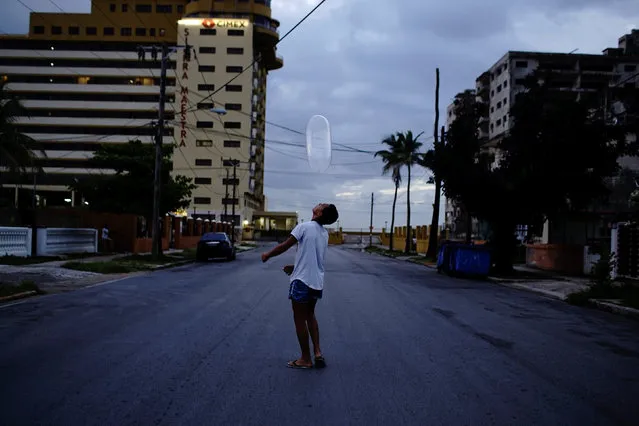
{"left": 71, "top": 140, "right": 196, "bottom": 218}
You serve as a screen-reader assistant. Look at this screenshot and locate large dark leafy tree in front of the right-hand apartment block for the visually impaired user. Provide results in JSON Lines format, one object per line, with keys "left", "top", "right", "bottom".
{"left": 443, "top": 75, "right": 637, "bottom": 272}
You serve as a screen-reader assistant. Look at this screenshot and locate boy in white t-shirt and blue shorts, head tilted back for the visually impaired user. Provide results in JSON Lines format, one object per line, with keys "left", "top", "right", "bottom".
{"left": 262, "top": 204, "right": 339, "bottom": 369}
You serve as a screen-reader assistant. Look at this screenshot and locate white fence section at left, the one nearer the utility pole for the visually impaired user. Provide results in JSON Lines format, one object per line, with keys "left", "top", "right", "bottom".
{"left": 36, "top": 228, "right": 98, "bottom": 256}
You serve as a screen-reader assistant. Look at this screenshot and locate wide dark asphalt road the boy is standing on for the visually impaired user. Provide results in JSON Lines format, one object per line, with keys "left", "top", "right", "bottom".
{"left": 0, "top": 248, "right": 639, "bottom": 426}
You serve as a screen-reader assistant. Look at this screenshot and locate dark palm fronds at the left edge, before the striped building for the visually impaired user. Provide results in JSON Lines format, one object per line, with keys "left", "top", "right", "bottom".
{"left": 0, "top": 83, "right": 45, "bottom": 179}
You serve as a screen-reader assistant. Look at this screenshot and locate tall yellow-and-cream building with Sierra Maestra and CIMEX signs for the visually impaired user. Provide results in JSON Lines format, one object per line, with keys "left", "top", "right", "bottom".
{"left": 0, "top": 0, "right": 283, "bottom": 230}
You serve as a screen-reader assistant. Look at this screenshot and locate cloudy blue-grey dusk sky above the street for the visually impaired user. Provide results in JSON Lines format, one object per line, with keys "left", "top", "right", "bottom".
{"left": 0, "top": 0, "right": 639, "bottom": 229}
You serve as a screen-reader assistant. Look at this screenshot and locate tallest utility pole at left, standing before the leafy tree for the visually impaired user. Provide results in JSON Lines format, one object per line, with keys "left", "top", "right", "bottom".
{"left": 151, "top": 43, "right": 169, "bottom": 259}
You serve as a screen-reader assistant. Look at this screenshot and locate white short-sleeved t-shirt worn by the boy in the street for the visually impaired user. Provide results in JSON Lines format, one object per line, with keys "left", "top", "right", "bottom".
{"left": 291, "top": 221, "right": 328, "bottom": 290}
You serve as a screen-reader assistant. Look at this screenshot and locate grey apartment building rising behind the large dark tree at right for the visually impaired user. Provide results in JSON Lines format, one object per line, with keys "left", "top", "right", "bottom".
{"left": 445, "top": 30, "right": 639, "bottom": 238}
